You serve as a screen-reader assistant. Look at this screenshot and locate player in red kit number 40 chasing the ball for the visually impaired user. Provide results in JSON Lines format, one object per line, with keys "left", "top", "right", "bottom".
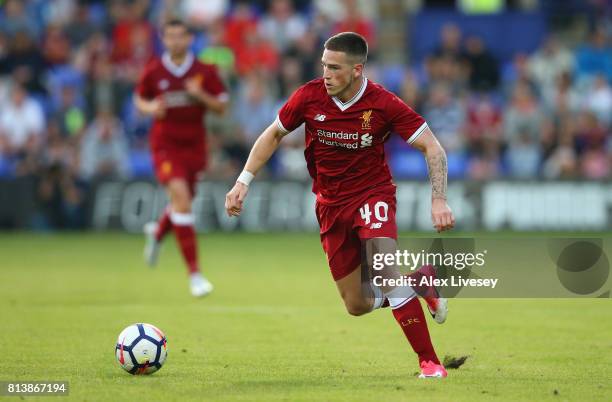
{"left": 225, "top": 32, "right": 454, "bottom": 378}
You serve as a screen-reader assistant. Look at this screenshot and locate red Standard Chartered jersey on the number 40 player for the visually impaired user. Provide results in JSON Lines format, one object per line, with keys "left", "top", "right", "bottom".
{"left": 276, "top": 77, "right": 427, "bottom": 205}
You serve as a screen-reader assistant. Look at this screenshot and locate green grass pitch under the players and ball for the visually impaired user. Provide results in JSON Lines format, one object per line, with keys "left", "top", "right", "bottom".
{"left": 0, "top": 233, "right": 612, "bottom": 401}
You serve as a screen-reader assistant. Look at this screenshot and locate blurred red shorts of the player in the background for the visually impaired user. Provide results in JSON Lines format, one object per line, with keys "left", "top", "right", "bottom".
{"left": 153, "top": 148, "right": 206, "bottom": 196}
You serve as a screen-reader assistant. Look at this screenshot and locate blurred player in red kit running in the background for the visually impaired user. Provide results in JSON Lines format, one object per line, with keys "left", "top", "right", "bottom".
{"left": 134, "top": 20, "right": 228, "bottom": 296}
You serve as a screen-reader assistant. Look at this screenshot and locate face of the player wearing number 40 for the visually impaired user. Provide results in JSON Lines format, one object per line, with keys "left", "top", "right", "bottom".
{"left": 321, "top": 49, "right": 363, "bottom": 97}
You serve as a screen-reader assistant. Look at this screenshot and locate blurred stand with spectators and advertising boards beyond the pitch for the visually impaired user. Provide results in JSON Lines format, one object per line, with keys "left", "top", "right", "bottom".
{"left": 0, "top": 0, "right": 612, "bottom": 232}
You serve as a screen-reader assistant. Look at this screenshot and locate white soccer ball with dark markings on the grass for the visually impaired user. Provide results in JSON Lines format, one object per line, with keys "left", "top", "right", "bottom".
{"left": 115, "top": 323, "right": 168, "bottom": 374}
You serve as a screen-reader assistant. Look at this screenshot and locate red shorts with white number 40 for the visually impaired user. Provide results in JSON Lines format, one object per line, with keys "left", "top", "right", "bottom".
{"left": 316, "top": 186, "right": 397, "bottom": 281}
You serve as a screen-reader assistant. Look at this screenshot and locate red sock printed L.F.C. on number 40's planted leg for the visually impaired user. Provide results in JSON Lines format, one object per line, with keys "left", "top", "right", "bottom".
{"left": 393, "top": 297, "right": 440, "bottom": 364}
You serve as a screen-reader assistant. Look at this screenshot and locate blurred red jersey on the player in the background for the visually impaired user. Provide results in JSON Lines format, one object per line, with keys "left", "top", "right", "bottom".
{"left": 136, "top": 53, "right": 227, "bottom": 150}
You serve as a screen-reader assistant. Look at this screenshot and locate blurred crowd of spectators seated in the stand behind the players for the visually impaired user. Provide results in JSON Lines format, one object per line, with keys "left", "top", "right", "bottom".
{"left": 0, "top": 0, "right": 612, "bottom": 221}
